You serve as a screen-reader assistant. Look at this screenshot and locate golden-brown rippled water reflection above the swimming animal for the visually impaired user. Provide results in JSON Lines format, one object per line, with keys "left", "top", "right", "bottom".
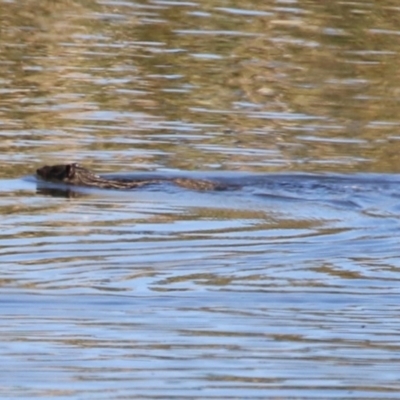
{"left": 0, "top": 0, "right": 400, "bottom": 176}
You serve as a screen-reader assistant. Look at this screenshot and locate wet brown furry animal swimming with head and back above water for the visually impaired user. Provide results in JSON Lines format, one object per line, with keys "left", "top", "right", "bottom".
{"left": 36, "top": 164, "right": 225, "bottom": 190}
